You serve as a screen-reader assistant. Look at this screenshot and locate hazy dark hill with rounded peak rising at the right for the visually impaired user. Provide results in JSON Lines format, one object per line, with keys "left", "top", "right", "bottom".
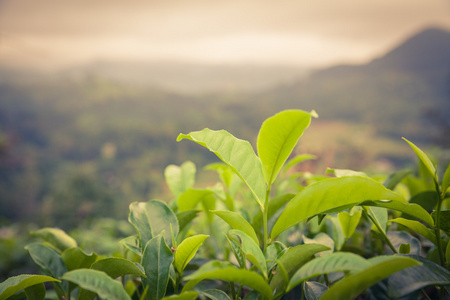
{"left": 253, "top": 28, "right": 450, "bottom": 144}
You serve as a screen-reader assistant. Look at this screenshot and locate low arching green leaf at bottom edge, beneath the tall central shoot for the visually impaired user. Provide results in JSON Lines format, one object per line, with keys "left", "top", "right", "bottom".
{"left": 182, "top": 261, "right": 272, "bottom": 299}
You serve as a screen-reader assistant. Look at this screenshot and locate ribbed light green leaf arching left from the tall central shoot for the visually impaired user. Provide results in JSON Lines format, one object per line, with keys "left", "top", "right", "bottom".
{"left": 177, "top": 128, "right": 266, "bottom": 209}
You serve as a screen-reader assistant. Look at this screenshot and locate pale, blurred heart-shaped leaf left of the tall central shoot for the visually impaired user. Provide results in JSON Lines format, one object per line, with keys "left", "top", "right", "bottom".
{"left": 164, "top": 161, "right": 197, "bottom": 198}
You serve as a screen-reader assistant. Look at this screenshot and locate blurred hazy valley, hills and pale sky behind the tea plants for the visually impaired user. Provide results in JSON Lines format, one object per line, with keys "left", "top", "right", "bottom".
{"left": 0, "top": 0, "right": 450, "bottom": 229}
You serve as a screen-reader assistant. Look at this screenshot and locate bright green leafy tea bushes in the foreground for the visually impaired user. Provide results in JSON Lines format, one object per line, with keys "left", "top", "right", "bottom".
{"left": 0, "top": 110, "right": 450, "bottom": 300}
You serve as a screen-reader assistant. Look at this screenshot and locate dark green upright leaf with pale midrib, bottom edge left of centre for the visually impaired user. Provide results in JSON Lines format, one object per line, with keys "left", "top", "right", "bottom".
{"left": 141, "top": 235, "right": 174, "bottom": 300}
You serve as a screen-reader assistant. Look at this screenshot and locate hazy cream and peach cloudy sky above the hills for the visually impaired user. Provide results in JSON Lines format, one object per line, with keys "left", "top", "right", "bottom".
{"left": 0, "top": 0, "right": 450, "bottom": 66}
